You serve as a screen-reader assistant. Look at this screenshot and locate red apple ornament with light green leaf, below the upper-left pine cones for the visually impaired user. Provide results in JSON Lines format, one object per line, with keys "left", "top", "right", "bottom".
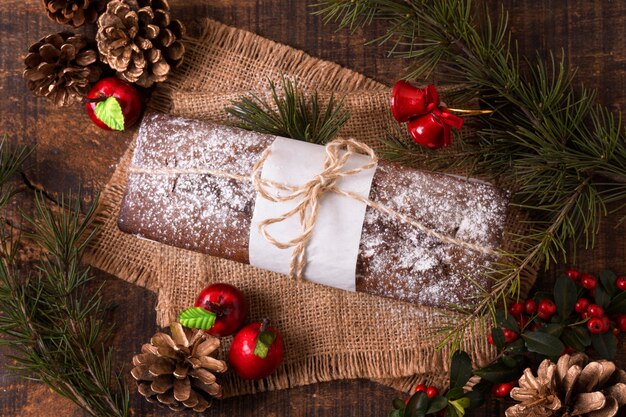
{"left": 85, "top": 77, "right": 141, "bottom": 130}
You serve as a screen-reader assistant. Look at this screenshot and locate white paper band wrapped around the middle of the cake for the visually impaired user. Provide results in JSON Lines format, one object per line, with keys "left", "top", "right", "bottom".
{"left": 249, "top": 138, "right": 376, "bottom": 291}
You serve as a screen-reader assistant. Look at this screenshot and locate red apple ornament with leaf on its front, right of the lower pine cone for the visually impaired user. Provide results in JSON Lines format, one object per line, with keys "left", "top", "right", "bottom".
{"left": 228, "top": 319, "right": 285, "bottom": 380}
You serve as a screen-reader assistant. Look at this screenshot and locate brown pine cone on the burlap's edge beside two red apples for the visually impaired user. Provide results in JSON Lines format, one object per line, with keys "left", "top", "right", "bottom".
{"left": 131, "top": 323, "right": 227, "bottom": 412}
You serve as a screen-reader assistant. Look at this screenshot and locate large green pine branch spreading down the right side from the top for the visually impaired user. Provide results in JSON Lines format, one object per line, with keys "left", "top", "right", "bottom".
{"left": 316, "top": 0, "right": 626, "bottom": 342}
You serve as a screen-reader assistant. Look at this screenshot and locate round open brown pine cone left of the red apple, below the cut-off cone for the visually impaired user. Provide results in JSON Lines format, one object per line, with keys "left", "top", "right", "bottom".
{"left": 23, "top": 32, "right": 102, "bottom": 106}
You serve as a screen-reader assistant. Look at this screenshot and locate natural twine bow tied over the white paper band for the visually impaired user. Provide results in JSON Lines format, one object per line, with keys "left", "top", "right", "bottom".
{"left": 252, "top": 139, "right": 378, "bottom": 278}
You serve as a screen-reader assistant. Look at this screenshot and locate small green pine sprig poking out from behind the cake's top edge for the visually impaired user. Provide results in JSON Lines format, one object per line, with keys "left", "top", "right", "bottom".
{"left": 226, "top": 77, "right": 349, "bottom": 144}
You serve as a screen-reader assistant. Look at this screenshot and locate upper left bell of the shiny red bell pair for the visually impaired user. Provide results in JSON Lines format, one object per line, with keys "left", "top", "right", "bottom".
{"left": 391, "top": 81, "right": 439, "bottom": 123}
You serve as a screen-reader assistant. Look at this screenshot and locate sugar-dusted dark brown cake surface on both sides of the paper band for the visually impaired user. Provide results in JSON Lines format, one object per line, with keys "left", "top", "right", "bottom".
{"left": 118, "top": 114, "right": 508, "bottom": 306}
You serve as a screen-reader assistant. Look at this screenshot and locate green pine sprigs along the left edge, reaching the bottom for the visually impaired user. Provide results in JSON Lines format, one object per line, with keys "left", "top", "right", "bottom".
{"left": 0, "top": 143, "right": 130, "bottom": 417}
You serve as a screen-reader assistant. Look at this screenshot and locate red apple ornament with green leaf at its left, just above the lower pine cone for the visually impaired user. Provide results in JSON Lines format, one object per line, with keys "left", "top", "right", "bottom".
{"left": 185, "top": 283, "right": 248, "bottom": 337}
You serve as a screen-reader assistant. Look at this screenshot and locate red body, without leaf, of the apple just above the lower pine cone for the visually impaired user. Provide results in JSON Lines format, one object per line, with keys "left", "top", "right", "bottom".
{"left": 194, "top": 283, "right": 248, "bottom": 337}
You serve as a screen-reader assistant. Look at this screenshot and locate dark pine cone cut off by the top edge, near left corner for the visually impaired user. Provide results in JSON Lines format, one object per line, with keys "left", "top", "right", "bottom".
{"left": 43, "top": 0, "right": 109, "bottom": 28}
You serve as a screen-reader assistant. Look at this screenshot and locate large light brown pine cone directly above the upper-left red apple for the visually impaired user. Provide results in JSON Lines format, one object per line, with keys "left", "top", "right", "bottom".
{"left": 96, "top": 0, "right": 185, "bottom": 87}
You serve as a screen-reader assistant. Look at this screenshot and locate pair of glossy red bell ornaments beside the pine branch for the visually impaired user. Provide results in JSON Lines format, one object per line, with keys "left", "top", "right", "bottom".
{"left": 391, "top": 81, "right": 463, "bottom": 149}
